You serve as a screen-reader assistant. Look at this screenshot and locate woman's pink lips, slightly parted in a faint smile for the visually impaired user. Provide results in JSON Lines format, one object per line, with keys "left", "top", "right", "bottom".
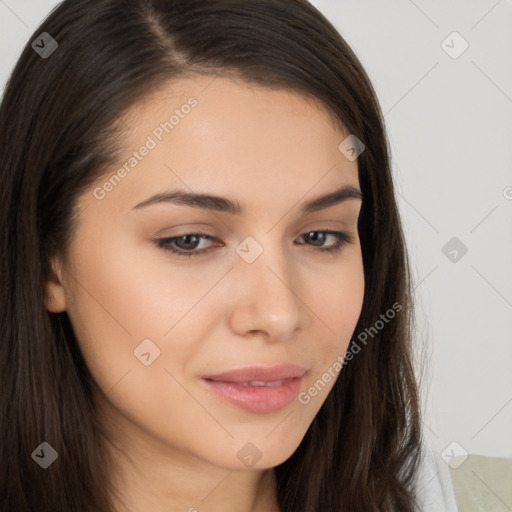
{"left": 201, "top": 364, "right": 307, "bottom": 413}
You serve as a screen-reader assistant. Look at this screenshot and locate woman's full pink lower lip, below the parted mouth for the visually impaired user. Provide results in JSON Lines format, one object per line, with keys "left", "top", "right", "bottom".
{"left": 201, "top": 377, "right": 303, "bottom": 413}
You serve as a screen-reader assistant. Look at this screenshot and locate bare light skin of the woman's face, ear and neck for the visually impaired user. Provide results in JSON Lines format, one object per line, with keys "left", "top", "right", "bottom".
{"left": 46, "top": 76, "right": 364, "bottom": 512}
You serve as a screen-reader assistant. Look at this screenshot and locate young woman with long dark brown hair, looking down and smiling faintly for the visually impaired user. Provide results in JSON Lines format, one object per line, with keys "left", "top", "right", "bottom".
{"left": 0, "top": 0, "right": 456, "bottom": 512}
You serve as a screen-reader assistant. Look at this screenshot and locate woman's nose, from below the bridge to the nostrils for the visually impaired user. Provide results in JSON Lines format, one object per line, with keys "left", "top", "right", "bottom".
{"left": 230, "top": 244, "right": 307, "bottom": 341}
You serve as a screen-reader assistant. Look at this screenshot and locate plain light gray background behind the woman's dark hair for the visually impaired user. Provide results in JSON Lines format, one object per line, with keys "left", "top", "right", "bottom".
{"left": 0, "top": 0, "right": 512, "bottom": 457}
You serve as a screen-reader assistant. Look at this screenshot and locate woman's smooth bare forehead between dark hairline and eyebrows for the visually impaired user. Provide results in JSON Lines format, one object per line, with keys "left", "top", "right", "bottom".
{"left": 81, "top": 76, "right": 358, "bottom": 218}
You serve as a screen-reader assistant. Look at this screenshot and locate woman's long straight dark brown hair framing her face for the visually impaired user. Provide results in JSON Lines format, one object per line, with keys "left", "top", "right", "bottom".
{"left": 0, "top": 0, "right": 421, "bottom": 512}
